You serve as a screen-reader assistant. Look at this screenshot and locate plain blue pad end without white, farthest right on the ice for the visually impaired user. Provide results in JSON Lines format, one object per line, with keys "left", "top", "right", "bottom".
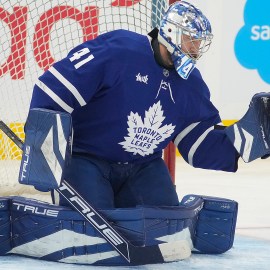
{"left": 182, "top": 195, "right": 238, "bottom": 254}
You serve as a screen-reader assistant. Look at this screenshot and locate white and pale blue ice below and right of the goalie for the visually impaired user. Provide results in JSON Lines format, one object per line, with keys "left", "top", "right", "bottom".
{"left": 0, "top": 157, "right": 270, "bottom": 270}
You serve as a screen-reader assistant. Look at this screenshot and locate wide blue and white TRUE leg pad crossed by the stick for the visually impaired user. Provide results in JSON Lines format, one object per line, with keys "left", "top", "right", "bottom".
{"left": 0, "top": 194, "right": 203, "bottom": 266}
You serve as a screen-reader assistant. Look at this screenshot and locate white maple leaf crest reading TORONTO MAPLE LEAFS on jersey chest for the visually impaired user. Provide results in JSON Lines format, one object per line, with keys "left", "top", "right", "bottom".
{"left": 119, "top": 101, "right": 175, "bottom": 156}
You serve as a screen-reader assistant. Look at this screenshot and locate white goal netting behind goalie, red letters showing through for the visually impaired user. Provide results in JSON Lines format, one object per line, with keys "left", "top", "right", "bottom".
{"left": 0, "top": 0, "right": 175, "bottom": 196}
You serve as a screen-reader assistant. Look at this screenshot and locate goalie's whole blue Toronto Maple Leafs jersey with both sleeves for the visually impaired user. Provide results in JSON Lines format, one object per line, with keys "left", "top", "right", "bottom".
{"left": 31, "top": 30, "right": 237, "bottom": 171}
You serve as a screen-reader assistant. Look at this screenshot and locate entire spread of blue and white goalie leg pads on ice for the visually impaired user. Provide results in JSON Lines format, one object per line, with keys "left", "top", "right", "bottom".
{"left": 0, "top": 195, "right": 237, "bottom": 266}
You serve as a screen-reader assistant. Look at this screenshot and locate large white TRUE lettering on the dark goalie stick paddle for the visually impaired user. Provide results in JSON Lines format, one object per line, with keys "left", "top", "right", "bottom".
{"left": 59, "top": 183, "right": 123, "bottom": 246}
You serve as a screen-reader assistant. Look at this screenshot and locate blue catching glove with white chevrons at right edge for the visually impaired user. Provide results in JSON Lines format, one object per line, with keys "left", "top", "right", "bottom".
{"left": 225, "top": 93, "right": 270, "bottom": 162}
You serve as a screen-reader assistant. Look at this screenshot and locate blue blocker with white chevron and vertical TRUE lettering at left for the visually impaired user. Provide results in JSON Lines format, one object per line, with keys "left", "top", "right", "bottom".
{"left": 19, "top": 109, "right": 72, "bottom": 191}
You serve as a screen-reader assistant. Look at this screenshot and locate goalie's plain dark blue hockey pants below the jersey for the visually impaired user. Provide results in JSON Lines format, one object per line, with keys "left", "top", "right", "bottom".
{"left": 59, "top": 154, "right": 179, "bottom": 209}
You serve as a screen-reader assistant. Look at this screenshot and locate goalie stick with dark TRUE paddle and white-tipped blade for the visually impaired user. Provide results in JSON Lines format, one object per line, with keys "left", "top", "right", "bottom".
{"left": 0, "top": 120, "right": 195, "bottom": 265}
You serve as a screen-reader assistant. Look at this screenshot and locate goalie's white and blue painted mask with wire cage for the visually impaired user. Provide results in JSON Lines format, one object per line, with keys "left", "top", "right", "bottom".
{"left": 158, "top": 1, "right": 213, "bottom": 79}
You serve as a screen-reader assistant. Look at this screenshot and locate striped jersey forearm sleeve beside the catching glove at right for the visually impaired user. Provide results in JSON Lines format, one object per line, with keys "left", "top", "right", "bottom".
{"left": 174, "top": 115, "right": 239, "bottom": 172}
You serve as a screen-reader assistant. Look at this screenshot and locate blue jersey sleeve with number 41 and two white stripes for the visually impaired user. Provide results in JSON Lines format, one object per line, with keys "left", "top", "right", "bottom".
{"left": 30, "top": 35, "right": 112, "bottom": 113}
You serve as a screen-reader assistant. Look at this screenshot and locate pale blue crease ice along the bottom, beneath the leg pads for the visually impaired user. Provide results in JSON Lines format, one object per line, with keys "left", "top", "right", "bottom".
{"left": 0, "top": 236, "right": 270, "bottom": 270}
